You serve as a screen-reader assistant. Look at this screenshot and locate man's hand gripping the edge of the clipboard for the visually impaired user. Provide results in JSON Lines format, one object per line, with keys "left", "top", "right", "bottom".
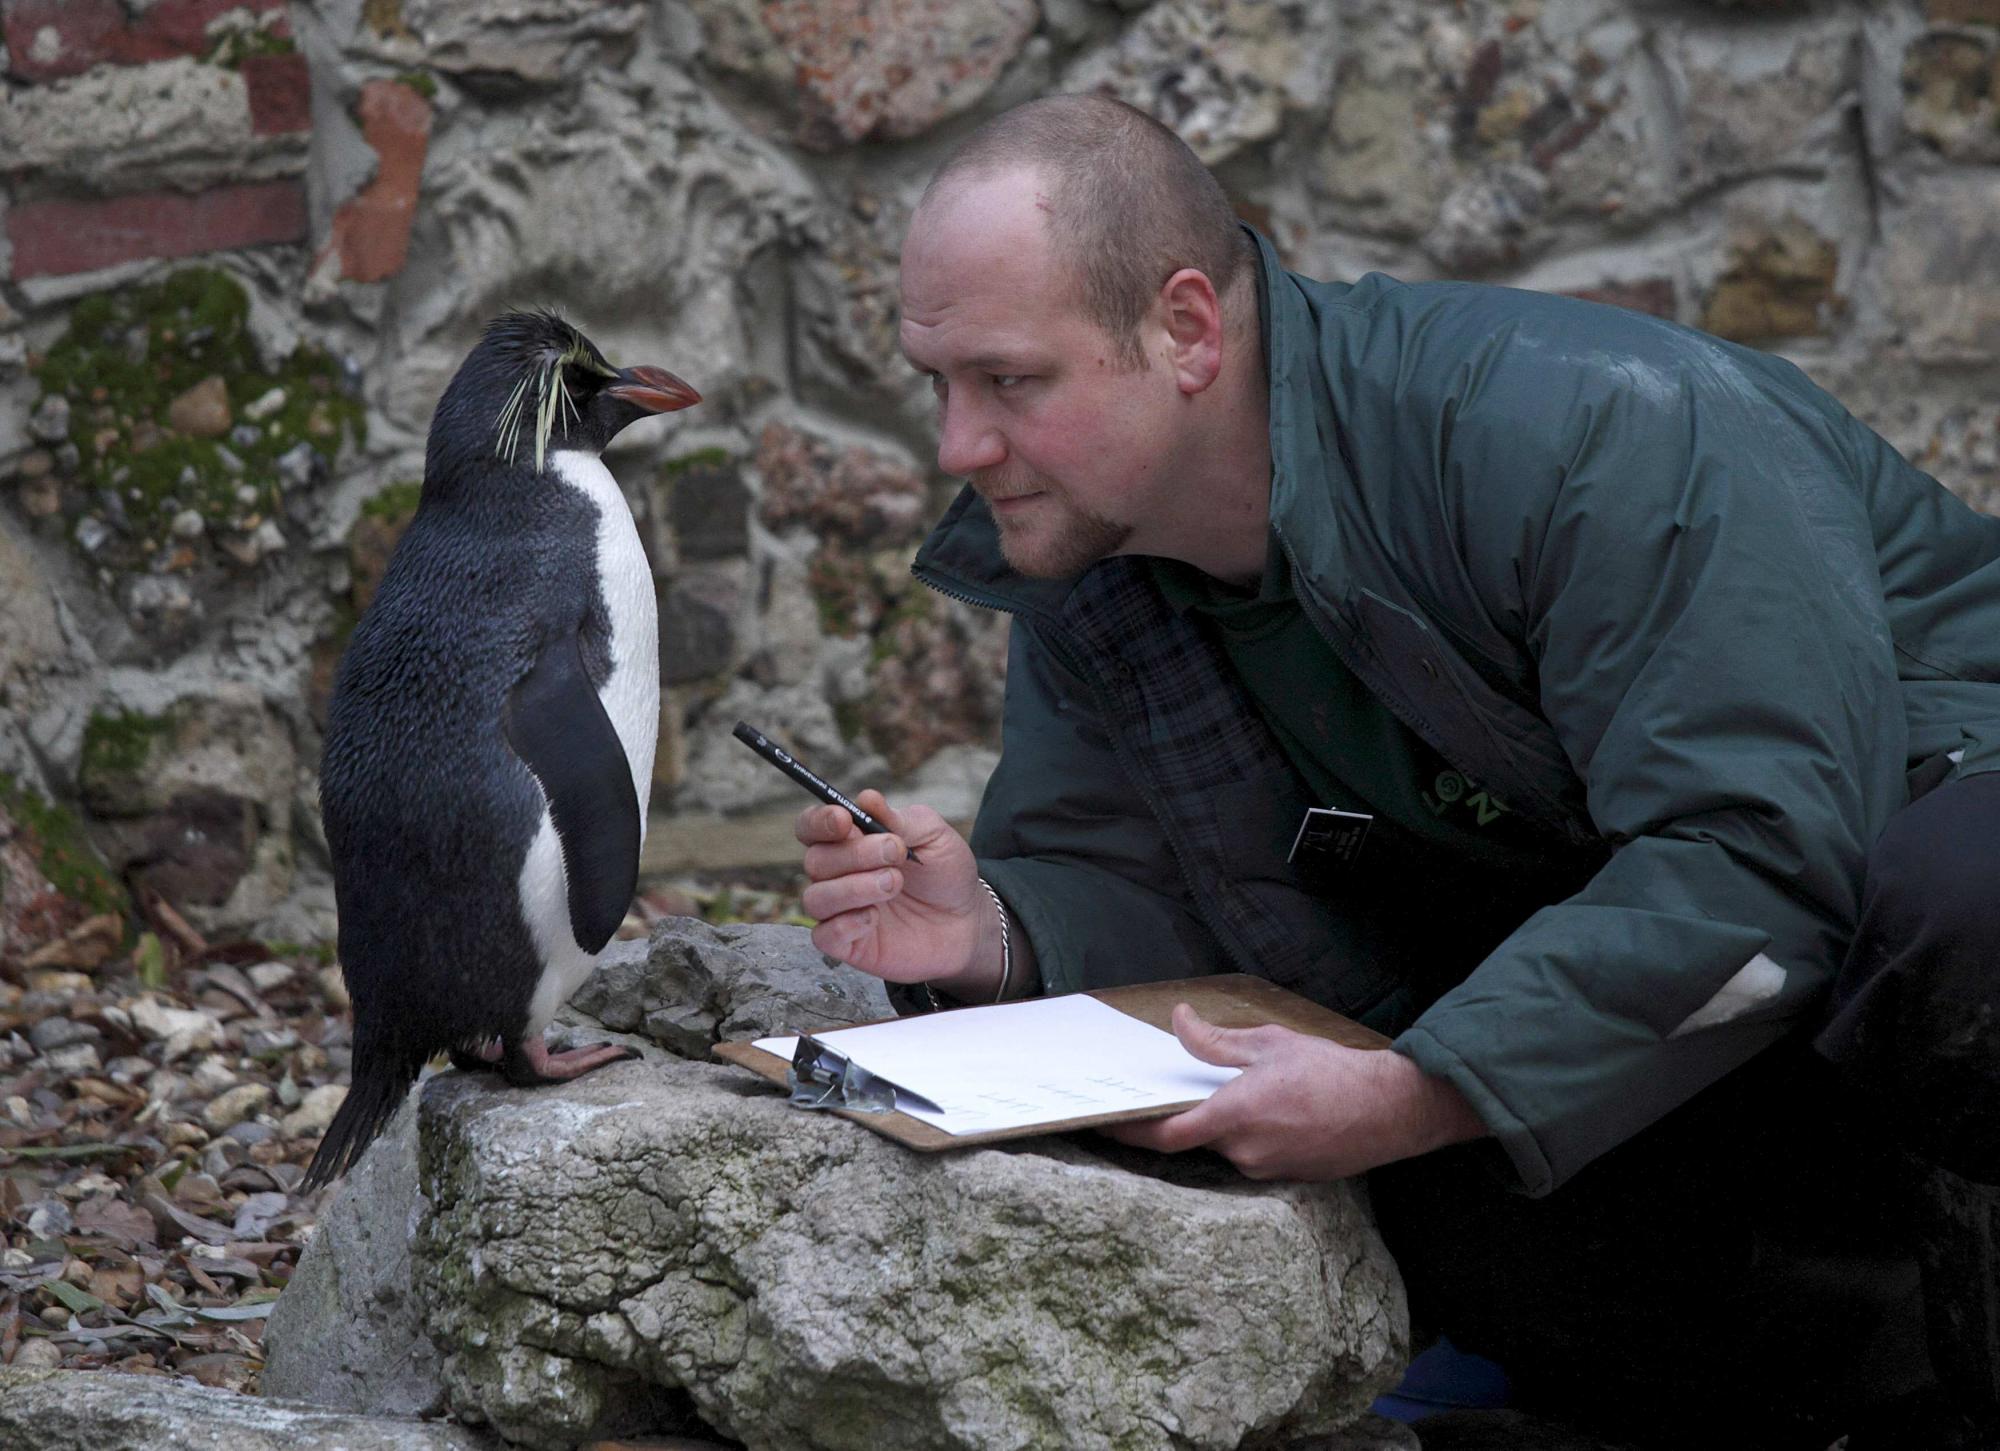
{"left": 1104, "top": 1003, "right": 1486, "bottom": 1179}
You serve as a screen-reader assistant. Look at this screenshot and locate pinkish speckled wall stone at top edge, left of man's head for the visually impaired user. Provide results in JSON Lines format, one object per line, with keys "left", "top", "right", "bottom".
{"left": 694, "top": 0, "right": 1038, "bottom": 150}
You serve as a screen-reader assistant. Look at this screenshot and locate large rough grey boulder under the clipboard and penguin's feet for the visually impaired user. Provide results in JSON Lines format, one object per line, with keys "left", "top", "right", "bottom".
{"left": 412, "top": 1057, "right": 1408, "bottom": 1451}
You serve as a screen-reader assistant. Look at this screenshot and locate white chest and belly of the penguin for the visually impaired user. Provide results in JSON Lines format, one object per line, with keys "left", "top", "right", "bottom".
{"left": 520, "top": 450, "right": 660, "bottom": 1033}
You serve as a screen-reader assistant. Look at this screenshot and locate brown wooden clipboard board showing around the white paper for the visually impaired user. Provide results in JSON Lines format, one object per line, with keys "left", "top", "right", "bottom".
{"left": 710, "top": 973, "right": 1388, "bottom": 1153}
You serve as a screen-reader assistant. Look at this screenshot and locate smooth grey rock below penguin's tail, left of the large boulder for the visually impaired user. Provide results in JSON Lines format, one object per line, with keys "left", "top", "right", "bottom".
{"left": 264, "top": 1095, "right": 444, "bottom": 1415}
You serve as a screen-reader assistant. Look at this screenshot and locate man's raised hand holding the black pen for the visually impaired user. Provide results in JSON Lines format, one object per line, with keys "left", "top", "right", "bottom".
{"left": 794, "top": 791, "right": 1000, "bottom": 999}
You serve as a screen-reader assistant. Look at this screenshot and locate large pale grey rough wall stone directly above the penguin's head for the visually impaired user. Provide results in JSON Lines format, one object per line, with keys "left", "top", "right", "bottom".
{"left": 368, "top": 68, "right": 818, "bottom": 437}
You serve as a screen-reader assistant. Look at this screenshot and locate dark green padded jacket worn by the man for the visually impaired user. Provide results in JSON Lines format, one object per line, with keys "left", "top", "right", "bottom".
{"left": 914, "top": 238, "right": 2000, "bottom": 1193}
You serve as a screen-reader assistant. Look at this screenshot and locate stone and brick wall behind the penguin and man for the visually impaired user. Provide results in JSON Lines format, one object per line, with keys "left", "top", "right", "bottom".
{"left": 0, "top": 0, "right": 2000, "bottom": 953}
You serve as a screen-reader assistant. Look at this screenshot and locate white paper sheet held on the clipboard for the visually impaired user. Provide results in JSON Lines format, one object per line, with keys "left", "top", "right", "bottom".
{"left": 756, "top": 993, "right": 1242, "bottom": 1133}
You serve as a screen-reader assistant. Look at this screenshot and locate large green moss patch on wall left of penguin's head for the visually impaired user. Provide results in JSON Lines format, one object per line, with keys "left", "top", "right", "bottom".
{"left": 36, "top": 268, "right": 366, "bottom": 570}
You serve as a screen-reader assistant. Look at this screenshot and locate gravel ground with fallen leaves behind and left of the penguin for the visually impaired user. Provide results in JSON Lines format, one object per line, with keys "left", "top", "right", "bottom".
{"left": 0, "top": 871, "right": 804, "bottom": 1391}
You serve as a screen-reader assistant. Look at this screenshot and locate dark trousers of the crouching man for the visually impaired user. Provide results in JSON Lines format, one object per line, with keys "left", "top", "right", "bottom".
{"left": 1370, "top": 775, "right": 2000, "bottom": 1451}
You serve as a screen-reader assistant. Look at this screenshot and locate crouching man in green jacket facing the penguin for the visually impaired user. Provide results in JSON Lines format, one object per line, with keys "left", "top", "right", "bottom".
{"left": 798, "top": 96, "right": 2000, "bottom": 1451}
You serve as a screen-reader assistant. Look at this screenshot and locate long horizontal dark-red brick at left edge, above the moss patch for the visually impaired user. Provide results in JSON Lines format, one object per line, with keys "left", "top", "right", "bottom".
{"left": 6, "top": 182, "right": 306, "bottom": 280}
